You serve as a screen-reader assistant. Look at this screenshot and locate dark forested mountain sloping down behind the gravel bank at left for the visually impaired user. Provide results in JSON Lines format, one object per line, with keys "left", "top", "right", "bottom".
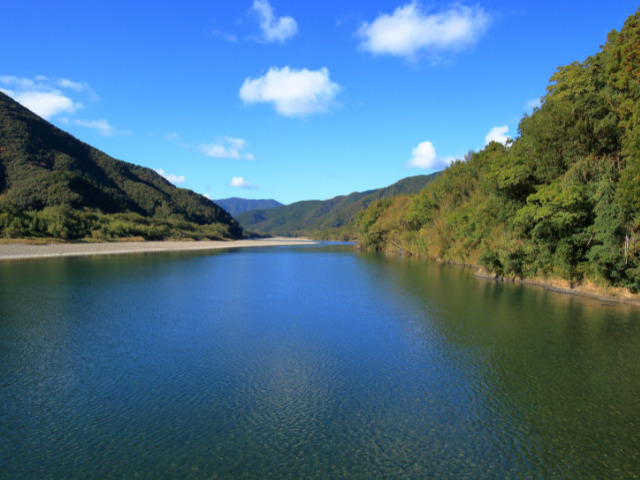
{"left": 0, "top": 92, "right": 242, "bottom": 239}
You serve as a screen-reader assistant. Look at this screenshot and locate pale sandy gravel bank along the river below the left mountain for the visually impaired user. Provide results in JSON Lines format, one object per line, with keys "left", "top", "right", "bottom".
{"left": 0, "top": 238, "right": 315, "bottom": 261}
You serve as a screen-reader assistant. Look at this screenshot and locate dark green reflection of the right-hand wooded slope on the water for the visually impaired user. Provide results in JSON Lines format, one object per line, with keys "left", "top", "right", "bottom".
{"left": 361, "top": 254, "right": 640, "bottom": 478}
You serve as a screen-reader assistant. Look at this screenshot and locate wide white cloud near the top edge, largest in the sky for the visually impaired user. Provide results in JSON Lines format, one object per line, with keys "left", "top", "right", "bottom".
{"left": 356, "top": 1, "right": 490, "bottom": 58}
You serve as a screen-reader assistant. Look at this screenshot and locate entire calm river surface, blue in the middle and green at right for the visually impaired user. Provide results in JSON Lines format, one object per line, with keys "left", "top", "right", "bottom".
{"left": 0, "top": 246, "right": 640, "bottom": 479}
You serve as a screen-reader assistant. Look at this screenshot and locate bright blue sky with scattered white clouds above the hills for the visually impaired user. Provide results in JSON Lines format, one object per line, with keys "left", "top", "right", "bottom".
{"left": 0, "top": 0, "right": 638, "bottom": 203}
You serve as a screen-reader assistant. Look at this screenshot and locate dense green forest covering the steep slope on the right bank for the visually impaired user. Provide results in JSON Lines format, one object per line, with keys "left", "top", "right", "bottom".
{"left": 357, "top": 9, "right": 640, "bottom": 292}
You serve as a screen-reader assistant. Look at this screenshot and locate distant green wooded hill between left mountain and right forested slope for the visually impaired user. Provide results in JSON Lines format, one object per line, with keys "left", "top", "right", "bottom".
{"left": 237, "top": 174, "right": 438, "bottom": 240}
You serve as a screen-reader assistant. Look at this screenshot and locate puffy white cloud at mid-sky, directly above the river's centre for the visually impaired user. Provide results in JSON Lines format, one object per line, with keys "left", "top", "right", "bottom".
{"left": 240, "top": 66, "right": 340, "bottom": 117}
